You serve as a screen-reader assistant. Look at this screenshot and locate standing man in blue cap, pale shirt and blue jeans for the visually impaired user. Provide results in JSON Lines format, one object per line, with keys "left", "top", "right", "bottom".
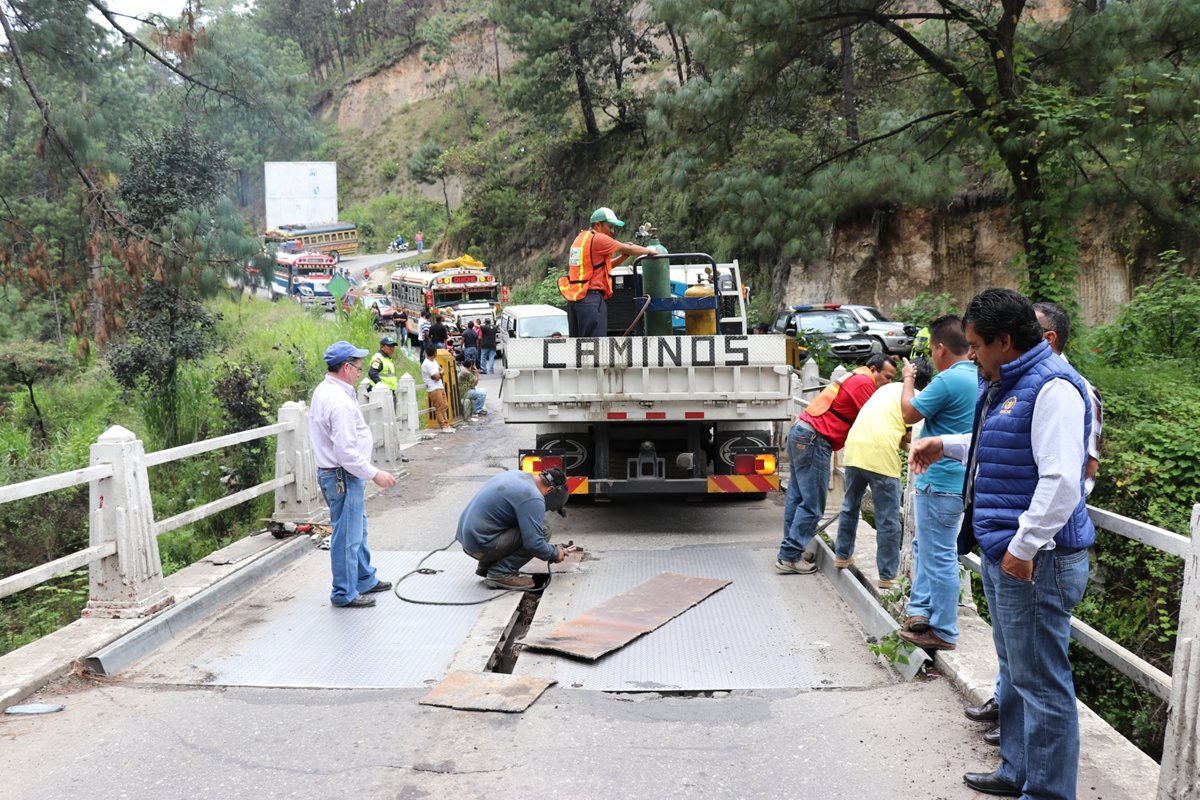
{"left": 308, "top": 342, "right": 396, "bottom": 608}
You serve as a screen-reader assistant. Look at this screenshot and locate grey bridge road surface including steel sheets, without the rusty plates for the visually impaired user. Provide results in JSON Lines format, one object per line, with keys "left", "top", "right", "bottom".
{"left": 0, "top": 383, "right": 1157, "bottom": 800}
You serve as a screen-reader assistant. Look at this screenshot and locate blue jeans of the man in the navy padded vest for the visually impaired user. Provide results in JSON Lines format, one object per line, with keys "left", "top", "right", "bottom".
{"left": 983, "top": 549, "right": 1087, "bottom": 800}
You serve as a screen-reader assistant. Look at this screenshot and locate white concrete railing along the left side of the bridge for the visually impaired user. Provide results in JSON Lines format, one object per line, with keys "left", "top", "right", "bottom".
{"left": 0, "top": 375, "right": 420, "bottom": 618}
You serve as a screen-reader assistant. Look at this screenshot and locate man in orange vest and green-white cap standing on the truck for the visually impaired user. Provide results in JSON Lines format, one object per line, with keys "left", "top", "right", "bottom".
{"left": 558, "top": 207, "right": 658, "bottom": 336}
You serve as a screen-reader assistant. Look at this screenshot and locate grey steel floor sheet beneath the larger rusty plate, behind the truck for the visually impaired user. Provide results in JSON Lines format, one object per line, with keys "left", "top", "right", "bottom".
{"left": 515, "top": 547, "right": 895, "bottom": 692}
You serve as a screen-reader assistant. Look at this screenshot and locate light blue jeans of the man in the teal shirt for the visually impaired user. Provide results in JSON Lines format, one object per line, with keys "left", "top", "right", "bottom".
{"left": 908, "top": 487, "right": 962, "bottom": 642}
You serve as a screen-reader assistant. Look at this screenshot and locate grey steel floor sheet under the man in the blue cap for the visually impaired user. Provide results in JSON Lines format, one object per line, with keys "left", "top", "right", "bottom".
{"left": 131, "top": 548, "right": 515, "bottom": 688}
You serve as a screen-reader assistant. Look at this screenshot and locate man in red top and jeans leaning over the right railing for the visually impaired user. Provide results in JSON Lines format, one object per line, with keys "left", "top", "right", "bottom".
{"left": 775, "top": 353, "right": 896, "bottom": 575}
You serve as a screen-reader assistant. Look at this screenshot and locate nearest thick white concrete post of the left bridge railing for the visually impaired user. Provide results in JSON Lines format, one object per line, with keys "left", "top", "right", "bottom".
{"left": 83, "top": 425, "right": 175, "bottom": 619}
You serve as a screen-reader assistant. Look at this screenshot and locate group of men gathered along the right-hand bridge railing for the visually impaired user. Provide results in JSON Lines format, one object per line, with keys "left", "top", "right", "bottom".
{"left": 775, "top": 289, "right": 1103, "bottom": 800}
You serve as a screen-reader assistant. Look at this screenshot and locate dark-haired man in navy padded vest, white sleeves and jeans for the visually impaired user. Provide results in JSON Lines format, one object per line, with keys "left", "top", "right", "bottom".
{"left": 908, "top": 289, "right": 1096, "bottom": 800}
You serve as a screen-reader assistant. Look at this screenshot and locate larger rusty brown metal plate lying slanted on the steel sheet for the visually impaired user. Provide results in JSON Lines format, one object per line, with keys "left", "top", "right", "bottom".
{"left": 524, "top": 572, "right": 731, "bottom": 661}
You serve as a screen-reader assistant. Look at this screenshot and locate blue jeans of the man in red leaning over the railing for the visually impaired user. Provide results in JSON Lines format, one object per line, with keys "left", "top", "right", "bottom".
{"left": 779, "top": 421, "right": 833, "bottom": 561}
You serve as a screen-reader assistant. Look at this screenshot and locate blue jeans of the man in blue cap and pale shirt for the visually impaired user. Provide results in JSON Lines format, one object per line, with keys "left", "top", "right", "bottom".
{"left": 317, "top": 469, "right": 379, "bottom": 606}
